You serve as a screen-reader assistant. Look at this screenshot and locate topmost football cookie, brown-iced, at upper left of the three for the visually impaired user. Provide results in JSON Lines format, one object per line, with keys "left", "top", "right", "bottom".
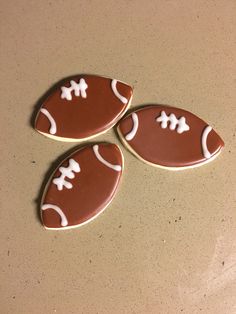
{"left": 35, "top": 75, "right": 133, "bottom": 141}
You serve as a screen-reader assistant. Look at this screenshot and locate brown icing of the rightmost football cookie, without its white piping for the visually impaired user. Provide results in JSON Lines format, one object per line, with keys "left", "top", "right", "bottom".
{"left": 118, "top": 105, "right": 224, "bottom": 167}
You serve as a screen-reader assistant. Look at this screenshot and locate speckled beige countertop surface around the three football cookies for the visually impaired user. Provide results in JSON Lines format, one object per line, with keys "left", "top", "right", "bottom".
{"left": 0, "top": 0, "right": 236, "bottom": 314}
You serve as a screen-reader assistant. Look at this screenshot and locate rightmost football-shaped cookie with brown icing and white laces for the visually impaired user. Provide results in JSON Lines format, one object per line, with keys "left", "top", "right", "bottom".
{"left": 118, "top": 105, "right": 224, "bottom": 170}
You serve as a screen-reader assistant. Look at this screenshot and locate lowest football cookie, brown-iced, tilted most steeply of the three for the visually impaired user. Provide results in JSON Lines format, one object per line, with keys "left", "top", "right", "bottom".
{"left": 41, "top": 143, "right": 123, "bottom": 229}
